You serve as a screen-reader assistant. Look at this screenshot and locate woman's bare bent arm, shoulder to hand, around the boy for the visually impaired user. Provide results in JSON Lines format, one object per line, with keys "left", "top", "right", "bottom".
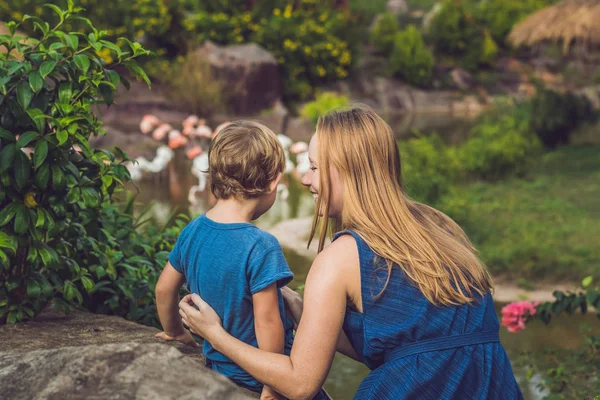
{"left": 180, "top": 241, "right": 359, "bottom": 399}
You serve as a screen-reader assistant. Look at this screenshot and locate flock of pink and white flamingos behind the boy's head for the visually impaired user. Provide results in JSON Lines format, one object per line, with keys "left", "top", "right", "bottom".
{"left": 127, "top": 114, "right": 310, "bottom": 205}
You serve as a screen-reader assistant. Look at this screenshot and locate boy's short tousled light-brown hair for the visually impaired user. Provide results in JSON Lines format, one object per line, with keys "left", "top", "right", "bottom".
{"left": 208, "top": 120, "right": 285, "bottom": 199}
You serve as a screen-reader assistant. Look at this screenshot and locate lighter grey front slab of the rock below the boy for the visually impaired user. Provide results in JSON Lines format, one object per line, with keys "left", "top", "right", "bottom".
{"left": 0, "top": 343, "right": 251, "bottom": 400}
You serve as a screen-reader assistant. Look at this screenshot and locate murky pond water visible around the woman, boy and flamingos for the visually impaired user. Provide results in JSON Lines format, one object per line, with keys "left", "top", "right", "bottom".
{"left": 125, "top": 113, "right": 600, "bottom": 400}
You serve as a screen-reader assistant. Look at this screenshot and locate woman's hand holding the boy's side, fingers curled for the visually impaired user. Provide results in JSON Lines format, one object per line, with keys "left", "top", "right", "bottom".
{"left": 179, "top": 293, "right": 223, "bottom": 342}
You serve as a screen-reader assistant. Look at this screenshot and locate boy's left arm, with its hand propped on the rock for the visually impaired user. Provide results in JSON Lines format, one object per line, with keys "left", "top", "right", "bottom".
{"left": 155, "top": 262, "right": 198, "bottom": 346}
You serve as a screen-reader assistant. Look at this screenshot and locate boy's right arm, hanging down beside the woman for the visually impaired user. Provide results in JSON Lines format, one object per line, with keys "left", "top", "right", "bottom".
{"left": 252, "top": 283, "right": 285, "bottom": 399}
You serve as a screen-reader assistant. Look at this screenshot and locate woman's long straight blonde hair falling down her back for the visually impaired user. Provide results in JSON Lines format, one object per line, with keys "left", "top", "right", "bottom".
{"left": 309, "top": 106, "right": 493, "bottom": 305}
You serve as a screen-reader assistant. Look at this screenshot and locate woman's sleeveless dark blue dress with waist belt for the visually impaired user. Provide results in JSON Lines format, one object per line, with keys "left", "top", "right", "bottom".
{"left": 333, "top": 231, "right": 523, "bottom": 400}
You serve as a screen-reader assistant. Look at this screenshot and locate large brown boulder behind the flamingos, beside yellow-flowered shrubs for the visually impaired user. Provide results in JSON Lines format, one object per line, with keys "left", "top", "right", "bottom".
{"left": 195, "top": 41, "right": 282, "bottom": 114}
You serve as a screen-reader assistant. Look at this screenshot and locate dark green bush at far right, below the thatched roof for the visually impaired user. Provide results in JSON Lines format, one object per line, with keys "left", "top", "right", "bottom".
{"left": 531, "top": 89, "right": 597, "bottom": 148}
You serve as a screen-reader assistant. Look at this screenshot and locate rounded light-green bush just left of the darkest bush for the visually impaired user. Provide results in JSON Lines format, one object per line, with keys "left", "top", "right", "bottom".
{"left": 458, "top": 104, "right": 540, "bottom": 180}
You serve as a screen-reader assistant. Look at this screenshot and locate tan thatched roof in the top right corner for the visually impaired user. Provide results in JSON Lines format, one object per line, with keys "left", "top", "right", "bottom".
{"left": 508, "top": 0, "right": 600, "bottom": 53}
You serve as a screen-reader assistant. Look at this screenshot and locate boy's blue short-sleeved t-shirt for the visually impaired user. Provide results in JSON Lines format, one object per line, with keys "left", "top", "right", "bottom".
{"left": 169, "top": 214, "right": 294, "bottom": 391}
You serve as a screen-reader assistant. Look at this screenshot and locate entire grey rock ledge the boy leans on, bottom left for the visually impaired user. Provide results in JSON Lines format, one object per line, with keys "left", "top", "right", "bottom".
{"left": 0, "top": 311, "right": 255, "bottom": 400}
